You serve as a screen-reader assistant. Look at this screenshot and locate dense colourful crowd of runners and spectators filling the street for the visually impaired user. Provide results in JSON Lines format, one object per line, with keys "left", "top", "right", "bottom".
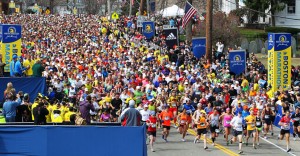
{"left": 1, "top": 14, "right": 300, "bottom": 153}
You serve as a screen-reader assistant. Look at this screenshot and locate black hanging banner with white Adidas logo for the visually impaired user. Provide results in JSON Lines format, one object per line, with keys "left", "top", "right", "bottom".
{"left": 163, "top": 27, "right": 178, "bottom": 49}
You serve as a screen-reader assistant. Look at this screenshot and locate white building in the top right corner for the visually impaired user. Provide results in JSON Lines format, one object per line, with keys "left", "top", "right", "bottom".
{"left": 275, "top": 0, "right": 300, "bottom": 28}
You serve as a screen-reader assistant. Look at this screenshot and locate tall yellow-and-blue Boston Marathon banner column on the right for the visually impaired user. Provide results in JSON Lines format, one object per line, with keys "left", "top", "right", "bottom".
{"left": 268, "top": 33, "right": 292, "bottom": 92}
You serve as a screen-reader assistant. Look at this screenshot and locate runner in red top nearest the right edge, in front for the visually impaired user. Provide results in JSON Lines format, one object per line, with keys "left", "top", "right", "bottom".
{"left": 278, "top": 111, "right": 291, "bottom": 152}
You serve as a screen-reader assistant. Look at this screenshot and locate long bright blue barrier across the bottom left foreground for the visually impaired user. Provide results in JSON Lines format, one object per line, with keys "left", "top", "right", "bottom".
{"left": 0, "top": 126, "right": 147, "bottom": 156}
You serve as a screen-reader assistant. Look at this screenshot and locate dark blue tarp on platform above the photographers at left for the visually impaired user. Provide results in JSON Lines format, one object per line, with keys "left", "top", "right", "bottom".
{"left": 0, "top": 77, "right": 46, "bottom": 102}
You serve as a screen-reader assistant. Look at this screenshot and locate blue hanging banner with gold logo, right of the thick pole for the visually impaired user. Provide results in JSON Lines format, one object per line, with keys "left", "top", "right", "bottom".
{"left": 229, "top": 50, "right": 246, "bottom": 75}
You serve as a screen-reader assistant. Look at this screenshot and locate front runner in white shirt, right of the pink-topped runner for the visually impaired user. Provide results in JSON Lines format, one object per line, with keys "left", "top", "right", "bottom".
{"left": 230, "top": 111, "right": 243, "bottom": 154}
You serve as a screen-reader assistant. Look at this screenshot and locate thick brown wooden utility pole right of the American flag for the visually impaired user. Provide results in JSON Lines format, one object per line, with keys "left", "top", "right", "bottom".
{"left": 206, "top": 0, "right": 213, "bottom": 63}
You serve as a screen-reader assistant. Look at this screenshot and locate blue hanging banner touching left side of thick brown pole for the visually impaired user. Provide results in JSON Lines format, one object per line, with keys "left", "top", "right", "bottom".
{"left": 192, "top": 37, "right": 206, "bottom": 59}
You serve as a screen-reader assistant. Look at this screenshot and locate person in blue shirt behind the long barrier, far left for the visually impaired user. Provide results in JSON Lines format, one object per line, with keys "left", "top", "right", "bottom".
{"left": 3, "top": 92, "right": 22, "bottom": 122}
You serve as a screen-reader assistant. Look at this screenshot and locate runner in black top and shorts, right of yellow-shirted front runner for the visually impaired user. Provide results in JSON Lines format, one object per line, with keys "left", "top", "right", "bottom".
{"left": 262, "top": 104, "right": 275, "bottom": 139}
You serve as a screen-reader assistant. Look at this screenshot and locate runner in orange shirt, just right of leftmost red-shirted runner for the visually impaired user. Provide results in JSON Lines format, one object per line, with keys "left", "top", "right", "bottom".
{"left": 160, "top": 105, "right": 173, "bottom": 142}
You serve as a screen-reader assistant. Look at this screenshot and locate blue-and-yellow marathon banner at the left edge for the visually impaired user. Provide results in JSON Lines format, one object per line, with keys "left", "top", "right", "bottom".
{"left": 1, "top": 24, "right": 22, "bottom": 72}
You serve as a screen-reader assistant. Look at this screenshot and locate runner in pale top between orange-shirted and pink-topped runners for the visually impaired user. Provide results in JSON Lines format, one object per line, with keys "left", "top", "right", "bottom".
{"left": 208, "top": 108, "right": 220, "bottom": 146}
